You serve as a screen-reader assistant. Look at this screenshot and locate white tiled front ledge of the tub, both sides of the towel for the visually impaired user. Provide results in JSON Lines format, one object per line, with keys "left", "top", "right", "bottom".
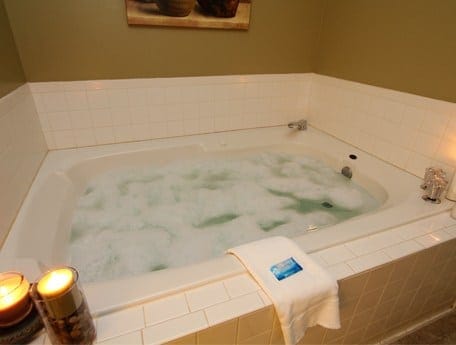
{"left": 29, "top": 212, "right": 456, "bottom": 345}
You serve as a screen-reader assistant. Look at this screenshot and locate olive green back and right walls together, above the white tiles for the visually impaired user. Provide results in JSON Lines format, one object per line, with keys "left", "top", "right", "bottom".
{"left": 4, "top": 0, "right": 456, "bottom": 102}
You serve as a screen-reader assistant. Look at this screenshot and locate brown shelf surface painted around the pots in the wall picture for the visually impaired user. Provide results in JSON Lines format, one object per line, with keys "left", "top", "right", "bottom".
{"left": 125, "top": 0, "right": 251, "bottom": 30}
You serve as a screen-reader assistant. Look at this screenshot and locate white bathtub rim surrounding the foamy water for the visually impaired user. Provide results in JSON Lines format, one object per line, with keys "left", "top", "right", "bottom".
{"left": 0, "top": 126, "right": 451, "bottom": 313}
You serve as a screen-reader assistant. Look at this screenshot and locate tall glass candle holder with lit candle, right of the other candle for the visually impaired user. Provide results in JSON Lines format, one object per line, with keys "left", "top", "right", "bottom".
{"left": 31, "top": 267, "right": 96, "bottom": 345}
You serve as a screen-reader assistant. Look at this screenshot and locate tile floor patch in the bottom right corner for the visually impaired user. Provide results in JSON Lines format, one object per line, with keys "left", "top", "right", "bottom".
{"left": 391, "top": 311, "right": 456, "bottom": 345}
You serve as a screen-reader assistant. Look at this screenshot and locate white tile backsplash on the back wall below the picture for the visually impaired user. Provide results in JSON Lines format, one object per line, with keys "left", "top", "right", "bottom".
{"left": 30, "top": 74, "right": 311, "bottom": 149}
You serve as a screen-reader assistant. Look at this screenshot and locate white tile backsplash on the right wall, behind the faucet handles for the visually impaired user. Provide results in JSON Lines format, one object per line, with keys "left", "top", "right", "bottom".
{"left": 308, "top": 75, "right": 456, "bottom": 176}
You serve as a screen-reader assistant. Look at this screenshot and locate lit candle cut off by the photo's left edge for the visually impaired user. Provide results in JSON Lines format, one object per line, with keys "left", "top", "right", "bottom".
{"left": 0, "top": 272, "right": 32, "bottom": 327}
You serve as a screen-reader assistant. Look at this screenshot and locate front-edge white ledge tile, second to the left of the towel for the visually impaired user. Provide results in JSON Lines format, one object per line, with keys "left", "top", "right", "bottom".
{"left": 142, "top": 311, "right": 208, "bottom": 345}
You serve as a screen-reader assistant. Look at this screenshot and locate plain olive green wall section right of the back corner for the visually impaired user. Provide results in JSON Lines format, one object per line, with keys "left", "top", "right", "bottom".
{"left": 315, "top": 0, "right": 456, "bottom": 102}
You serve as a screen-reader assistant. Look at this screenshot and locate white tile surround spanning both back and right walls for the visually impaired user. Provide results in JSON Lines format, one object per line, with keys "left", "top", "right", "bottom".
{"left": 29, "top": 73, "right": 456, "bottom": 177}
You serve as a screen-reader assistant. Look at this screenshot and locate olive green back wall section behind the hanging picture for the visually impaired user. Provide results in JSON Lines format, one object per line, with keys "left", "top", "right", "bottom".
{"left": 5, "top": 0, "right": 324, "bottom": 81}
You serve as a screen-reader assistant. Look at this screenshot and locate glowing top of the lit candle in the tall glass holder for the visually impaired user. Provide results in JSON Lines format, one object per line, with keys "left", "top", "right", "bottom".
{"left": 37, "top": 268, "right": 75, "bottom": 299}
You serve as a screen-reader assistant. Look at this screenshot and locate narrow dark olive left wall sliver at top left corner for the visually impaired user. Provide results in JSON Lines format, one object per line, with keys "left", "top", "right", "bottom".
{"left": 0, "top": 0, "right": 25, "bottom": 98}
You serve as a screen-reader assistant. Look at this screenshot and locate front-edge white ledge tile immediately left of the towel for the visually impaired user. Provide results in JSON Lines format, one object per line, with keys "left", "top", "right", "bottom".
{"left": 204, "top": 292, "right": 264, "bottom": 326}
